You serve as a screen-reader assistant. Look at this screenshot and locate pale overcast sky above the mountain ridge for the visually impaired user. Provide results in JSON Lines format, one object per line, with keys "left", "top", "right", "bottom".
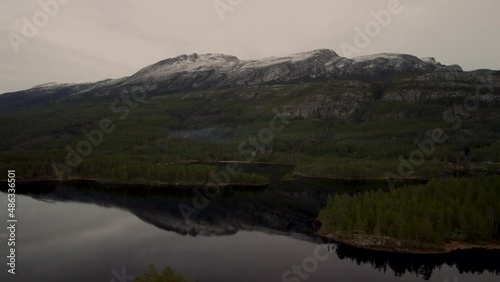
{"left": 0, "top": 0, "right": 500, "bottom": 93}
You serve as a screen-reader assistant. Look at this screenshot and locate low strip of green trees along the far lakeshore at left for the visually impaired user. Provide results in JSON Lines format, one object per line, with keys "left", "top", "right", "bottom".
{"left": 0, "top": 153, "right": 269, "bottom": 185}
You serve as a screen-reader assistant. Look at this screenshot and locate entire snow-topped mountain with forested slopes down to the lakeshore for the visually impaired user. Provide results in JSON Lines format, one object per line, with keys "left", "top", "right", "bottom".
{"left": 0, "top": 50, "right": 500, "bottom": 183}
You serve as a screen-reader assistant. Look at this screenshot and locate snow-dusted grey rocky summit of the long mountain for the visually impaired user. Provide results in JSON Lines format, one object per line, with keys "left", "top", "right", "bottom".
{"left": 112, "top": 49, "right": 462, "bottom": 91}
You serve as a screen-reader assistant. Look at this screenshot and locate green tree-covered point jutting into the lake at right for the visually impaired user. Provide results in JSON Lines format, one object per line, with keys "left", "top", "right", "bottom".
{"left": 319, "top": 176, "right": 500, "bottom": 250}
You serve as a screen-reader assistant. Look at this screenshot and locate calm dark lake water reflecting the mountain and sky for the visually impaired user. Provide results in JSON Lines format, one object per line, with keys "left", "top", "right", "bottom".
{"left": 0, "top": 178, "right": 500, "bottom": 282}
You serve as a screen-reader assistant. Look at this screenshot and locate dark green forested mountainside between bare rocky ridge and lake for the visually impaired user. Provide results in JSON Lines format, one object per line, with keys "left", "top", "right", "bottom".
{"left": 0, "top": 79, "right": 500, "bottom": 183}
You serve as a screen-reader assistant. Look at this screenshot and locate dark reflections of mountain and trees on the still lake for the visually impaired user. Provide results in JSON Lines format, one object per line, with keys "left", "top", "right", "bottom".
{"left": 0, "top": 180, "right": 500, "bottom": 281}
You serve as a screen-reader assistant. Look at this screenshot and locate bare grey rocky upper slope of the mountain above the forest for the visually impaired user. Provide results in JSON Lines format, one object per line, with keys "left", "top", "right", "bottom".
{"left": 0, "top": 49, "right": 500, "bottom": 114}
